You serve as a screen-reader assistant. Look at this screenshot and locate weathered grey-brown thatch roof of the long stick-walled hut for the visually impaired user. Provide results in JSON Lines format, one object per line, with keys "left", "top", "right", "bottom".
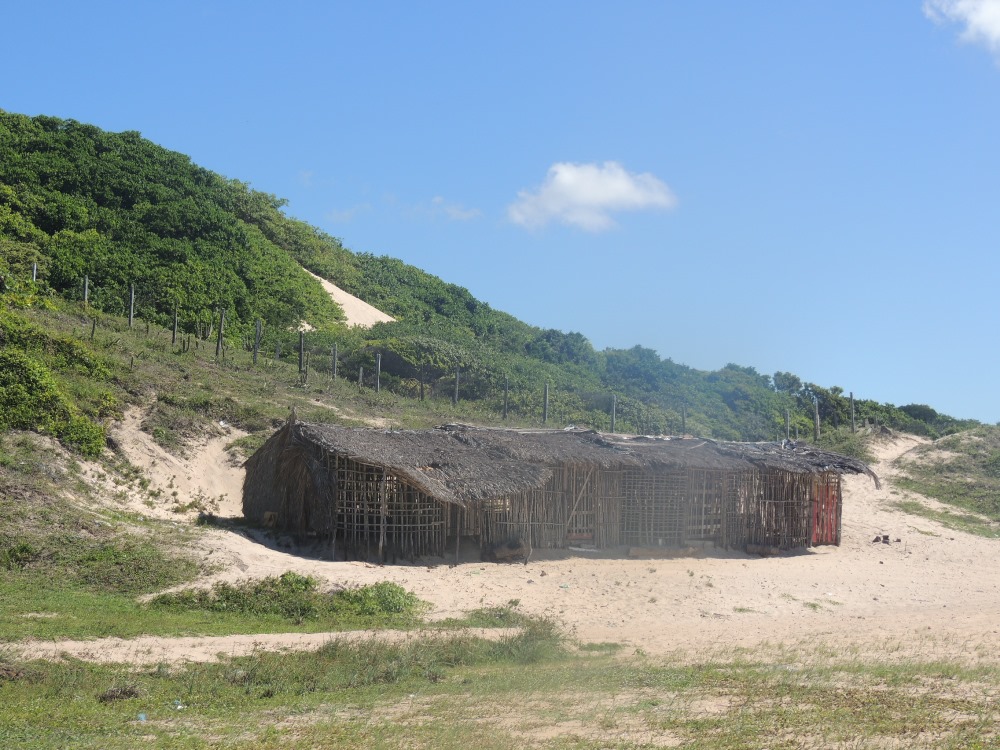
{"left": 248, "top": 422, "right": 878, "bottom": 505}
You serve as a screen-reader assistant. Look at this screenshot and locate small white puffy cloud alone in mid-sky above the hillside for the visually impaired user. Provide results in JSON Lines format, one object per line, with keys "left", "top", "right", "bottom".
{"left": 507, "top": 161, "right": 677, "bottom": 232}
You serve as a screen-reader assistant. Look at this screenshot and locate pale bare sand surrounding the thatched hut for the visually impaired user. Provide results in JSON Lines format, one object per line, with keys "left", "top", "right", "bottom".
{"left": 17, "top": 434, "right": 1000, "bottom": 660}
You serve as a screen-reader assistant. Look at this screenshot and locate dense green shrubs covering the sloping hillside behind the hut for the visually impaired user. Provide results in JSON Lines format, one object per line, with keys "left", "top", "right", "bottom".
{"left": 0, "top": 111, "right": 974, "bottom": 450}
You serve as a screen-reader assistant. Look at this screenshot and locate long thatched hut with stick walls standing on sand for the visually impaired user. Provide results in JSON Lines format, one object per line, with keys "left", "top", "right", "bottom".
{"left": 243, "top": 419, "right": 877, "bottom": 559}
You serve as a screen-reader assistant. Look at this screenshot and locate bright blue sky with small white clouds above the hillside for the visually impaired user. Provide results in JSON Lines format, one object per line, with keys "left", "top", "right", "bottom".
{"left": 0, "top": 0, "right": 1000, "bottom": 422}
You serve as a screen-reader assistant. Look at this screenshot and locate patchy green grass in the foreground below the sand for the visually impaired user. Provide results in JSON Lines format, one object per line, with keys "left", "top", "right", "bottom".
{"left": 0, "top": 636, "right": 1000, "bottom": 750}
